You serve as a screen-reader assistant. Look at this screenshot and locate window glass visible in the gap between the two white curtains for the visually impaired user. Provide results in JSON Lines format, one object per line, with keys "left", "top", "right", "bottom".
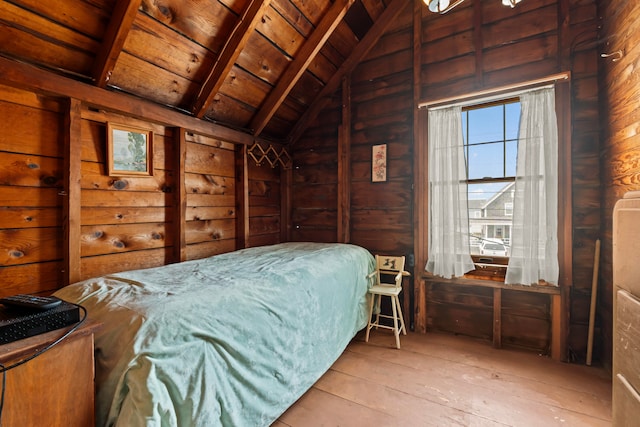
{"left": 461, "top": 98, "right": 520, "bottom": 260}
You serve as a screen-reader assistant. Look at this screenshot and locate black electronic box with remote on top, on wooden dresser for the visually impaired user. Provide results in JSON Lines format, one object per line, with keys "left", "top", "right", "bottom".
{"left": 0, "top": 299, "right": 80, "bottom": 344}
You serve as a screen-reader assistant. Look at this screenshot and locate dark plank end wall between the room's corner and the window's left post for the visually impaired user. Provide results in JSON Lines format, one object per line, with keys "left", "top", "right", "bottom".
{"left": 292, "top": 2, "right": 413, "bottom": 254}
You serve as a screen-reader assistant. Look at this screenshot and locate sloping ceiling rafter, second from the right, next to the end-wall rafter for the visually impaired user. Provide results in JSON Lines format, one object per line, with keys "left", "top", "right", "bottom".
{"left": 249, "top": 0, "right": 355, "bottom": 136}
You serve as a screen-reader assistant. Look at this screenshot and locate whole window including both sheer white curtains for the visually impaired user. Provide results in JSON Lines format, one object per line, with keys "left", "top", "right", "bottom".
{"left": 416, "top": 86, "right": 570, "bottom": 285}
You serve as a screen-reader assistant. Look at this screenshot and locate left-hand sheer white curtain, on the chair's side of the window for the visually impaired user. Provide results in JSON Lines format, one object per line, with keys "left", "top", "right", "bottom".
{"left": 425, "top": 106, "right": 474, "bottom": 279}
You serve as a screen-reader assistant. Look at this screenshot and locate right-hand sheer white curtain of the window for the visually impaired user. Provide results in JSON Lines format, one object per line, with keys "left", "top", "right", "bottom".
{"left": 505, "top": 87, "right": 558, "bottom": 285}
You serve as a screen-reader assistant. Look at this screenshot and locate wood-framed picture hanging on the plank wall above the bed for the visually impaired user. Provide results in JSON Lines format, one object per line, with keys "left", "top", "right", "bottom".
{"left": 107, "top": 122, "right": 153, "bottom": 176}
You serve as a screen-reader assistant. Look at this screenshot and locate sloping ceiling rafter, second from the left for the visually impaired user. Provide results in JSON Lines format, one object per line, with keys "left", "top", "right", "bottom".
{"left": 191, "top": 0, "right": 271, "bottom": 118}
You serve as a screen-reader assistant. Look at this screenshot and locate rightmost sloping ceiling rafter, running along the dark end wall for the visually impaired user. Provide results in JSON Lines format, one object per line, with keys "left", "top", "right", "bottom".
{"left": 287, "top": 0, "right": 411, "bottom": 144}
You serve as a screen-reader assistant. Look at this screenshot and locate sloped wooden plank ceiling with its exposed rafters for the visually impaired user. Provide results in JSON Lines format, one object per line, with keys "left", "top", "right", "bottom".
{"left": 0, "top": 0, "right": 410, "bottom": 142}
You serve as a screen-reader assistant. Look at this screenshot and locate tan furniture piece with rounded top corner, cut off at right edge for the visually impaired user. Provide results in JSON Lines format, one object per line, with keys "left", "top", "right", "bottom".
{"left": 612, "top": 191, "right": 640, "bottom": 426}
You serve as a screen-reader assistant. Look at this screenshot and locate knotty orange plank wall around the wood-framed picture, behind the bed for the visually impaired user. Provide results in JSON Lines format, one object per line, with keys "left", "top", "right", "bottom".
{"left": 81, "top": 113, "right": 241, "bottom": 278}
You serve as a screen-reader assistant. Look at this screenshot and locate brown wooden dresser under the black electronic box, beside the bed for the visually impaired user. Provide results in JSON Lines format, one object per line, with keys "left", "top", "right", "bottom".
{"left": 0, "top": 323, "right": 99, "bottom": 427}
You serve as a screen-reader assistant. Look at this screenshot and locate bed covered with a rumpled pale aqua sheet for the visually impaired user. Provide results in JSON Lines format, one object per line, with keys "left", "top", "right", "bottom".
{"left": 55, "top": 243, "right": 374, "bottom": 427}
